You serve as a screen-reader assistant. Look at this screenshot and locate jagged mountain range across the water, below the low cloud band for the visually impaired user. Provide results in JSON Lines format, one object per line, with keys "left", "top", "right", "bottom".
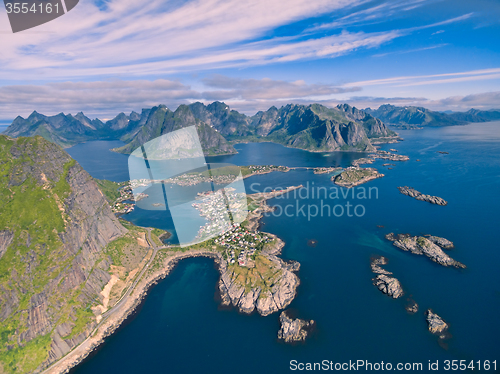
{"left": 4, "top": 102, "right": 396, "bottom": 155}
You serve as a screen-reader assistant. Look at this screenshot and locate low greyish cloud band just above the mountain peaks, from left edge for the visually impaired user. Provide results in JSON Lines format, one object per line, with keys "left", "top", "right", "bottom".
{"left": 0, "top": 75, "right": 360, "bottom": 120}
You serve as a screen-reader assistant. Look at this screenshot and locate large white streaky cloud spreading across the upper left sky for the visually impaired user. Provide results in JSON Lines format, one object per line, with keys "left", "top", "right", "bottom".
{"left": 0, "top": 0, "right": 376, "bottom": 80}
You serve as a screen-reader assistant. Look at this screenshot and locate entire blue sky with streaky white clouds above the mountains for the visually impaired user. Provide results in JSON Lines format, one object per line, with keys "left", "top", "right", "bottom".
{"left": 0, "top": 0, "right": 500, "bottom": 121}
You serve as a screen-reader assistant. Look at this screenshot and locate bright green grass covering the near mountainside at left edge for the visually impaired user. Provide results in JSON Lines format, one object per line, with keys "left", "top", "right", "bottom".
{"left": 0, "top": 136, "right": 74, "bottom": 372}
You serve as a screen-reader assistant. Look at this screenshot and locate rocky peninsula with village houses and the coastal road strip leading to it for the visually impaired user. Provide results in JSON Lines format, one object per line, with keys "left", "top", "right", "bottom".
{"left": 41, "top": 186, "right": 306, "bottom": 374}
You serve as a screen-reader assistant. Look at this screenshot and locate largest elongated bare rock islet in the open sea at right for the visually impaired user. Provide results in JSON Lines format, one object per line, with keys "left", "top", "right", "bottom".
{"left": 386, "top": 233, "right": 466, "bottom": 268}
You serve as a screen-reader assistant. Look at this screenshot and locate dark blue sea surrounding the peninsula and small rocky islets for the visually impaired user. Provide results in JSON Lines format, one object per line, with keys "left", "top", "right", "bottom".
{"left": 68, "top": 122, "right": 500, "bottom": 374}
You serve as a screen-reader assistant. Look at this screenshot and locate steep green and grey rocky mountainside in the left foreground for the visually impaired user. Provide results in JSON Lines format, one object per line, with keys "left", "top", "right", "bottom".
{"left": 0, "top": 136, "right": 127, "bottom": 373}
